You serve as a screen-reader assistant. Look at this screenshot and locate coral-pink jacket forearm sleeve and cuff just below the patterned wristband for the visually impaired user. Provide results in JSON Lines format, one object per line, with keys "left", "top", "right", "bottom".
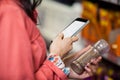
{"left": 35, "top": 60, "right": 68, "bottom": 80}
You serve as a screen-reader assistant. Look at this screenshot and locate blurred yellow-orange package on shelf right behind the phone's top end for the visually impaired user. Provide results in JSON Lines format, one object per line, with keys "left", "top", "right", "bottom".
{"left": 82, "top": 1, "right": 100, "bottom": 42}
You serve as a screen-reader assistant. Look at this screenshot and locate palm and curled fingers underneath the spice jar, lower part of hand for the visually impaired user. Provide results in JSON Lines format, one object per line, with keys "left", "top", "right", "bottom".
{"left": 69, "top": 57, "right": 102, "bottom": 79}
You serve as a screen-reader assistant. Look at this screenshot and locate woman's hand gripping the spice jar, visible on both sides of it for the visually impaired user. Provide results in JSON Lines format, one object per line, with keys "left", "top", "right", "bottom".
{"left": 63, "top": 46, "right": 102, "bottom": 79}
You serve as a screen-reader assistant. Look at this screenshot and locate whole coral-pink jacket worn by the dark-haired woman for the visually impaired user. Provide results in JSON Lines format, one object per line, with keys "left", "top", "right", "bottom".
{"left": 0, "top": 0, "right": 67, "bottom": 80}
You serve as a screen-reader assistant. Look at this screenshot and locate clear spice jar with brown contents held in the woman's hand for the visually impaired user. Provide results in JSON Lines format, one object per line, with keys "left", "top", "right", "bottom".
{"left": 71, "top": 39, "right": 110, "bottom": 74}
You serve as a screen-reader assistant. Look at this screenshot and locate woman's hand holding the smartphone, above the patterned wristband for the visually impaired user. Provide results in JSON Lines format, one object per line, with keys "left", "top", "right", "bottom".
{"left": 50, "top": 33, "right": 78, "bottom": 58}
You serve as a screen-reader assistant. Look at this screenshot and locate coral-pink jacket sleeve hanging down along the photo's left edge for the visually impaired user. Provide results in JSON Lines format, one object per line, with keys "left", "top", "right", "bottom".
{"left": 0, "top": 4, "right": 34, "bottom": 80}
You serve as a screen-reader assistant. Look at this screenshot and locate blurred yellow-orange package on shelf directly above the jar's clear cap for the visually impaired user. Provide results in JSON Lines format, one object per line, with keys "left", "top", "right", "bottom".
{"left": 100, "top": 8, "right": 112, "bottom": 41}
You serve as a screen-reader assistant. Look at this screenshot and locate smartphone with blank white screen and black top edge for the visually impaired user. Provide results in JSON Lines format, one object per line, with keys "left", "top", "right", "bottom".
{"left": 62, "top": 18, "right": 89, "bottom": 38}
